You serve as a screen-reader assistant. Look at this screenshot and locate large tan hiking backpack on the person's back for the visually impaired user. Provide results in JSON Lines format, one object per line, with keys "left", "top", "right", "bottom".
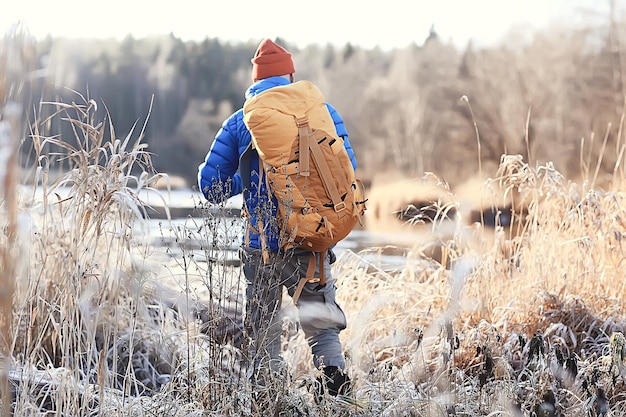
{"left": 243, "top": 81, "right": 366, "bottom": 301}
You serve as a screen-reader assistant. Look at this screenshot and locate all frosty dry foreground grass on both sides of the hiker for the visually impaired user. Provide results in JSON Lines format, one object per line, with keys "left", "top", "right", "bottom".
{"left": 2, "top": 98, "right": 626, "bottom": 416}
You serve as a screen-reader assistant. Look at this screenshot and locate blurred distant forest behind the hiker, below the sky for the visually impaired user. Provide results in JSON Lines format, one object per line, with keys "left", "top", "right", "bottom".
{"left": 0, "top": 10, "right": 626, "bottom": 186}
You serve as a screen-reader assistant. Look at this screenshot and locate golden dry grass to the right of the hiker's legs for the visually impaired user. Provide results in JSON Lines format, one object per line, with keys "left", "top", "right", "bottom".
{"left": 337, "top": 156, "right": 626, "bottom": 416}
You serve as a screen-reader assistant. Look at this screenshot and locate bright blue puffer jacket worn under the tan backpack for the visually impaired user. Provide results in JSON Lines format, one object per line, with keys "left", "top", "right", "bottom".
{"left": 198, "top": 77, "right": 357, "bottom": 252}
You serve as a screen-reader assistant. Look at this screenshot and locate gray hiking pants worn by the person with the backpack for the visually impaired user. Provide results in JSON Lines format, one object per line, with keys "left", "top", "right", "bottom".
{"left": 242, "top": 248, "right": 346, "bottom": 371}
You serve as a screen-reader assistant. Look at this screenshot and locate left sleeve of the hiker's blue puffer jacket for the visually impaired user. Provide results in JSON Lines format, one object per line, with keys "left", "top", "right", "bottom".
{"left": 198, "top": 110, "right": 242, "bottom": 203}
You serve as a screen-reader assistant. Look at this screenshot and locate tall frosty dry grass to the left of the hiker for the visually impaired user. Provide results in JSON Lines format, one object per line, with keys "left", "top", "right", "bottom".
{"left": 2, "top": 96, "right": 300, "bottom": 416}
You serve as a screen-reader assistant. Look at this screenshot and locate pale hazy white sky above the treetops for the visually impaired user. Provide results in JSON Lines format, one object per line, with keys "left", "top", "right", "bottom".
{"left": 0, "top": 0, "right": 612, "bottom": 49}
